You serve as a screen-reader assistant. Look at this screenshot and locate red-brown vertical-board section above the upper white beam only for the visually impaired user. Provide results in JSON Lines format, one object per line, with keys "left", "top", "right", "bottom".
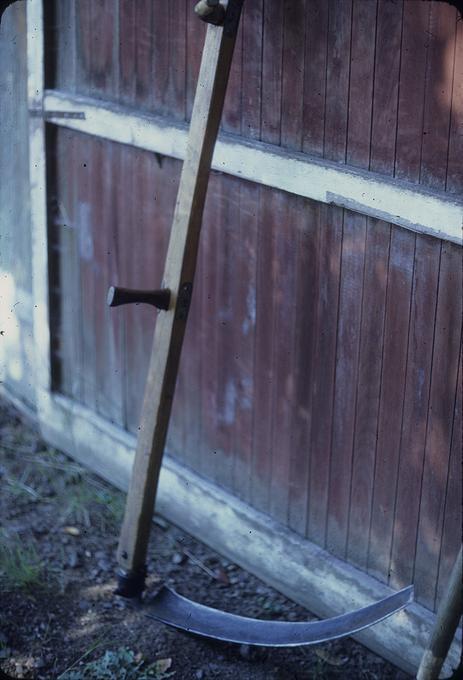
{"left": 50, "top": 0, "right": 463, "bottom": 193}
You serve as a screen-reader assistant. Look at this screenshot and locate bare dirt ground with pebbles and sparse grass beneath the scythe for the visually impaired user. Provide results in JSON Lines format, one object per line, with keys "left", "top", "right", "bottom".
{"left": 0, "top": 403, "right": 414, "bottom": 680}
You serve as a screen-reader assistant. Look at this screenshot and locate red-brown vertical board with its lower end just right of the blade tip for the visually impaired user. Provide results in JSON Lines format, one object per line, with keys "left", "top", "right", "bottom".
{"left": 414, "top": 243, "right": 463, "bottom": 608}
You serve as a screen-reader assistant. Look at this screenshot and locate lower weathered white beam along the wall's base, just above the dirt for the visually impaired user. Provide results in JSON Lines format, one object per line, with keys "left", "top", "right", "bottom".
{"left": 21, "top": 391, "right": 461, "bottom": 673}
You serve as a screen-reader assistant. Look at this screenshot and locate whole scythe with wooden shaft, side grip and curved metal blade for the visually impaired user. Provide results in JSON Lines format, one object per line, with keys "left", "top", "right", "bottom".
{"left": 108, "top": 0, "right": 413, "bottom": 647}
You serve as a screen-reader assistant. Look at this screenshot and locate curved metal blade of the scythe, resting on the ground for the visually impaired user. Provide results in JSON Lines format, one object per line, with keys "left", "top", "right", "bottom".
{"left": 146, "top": 586, "right": 413, "bottom": 647}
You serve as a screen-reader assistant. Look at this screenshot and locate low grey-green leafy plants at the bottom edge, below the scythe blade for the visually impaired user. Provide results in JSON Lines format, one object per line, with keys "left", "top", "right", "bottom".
{"left": 57, "top": 647, "right": 174, "bottom": 680}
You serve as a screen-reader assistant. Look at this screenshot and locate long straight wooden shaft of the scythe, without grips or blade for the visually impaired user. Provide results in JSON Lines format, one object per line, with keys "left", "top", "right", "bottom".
{"left": 113, "top": 0, "right": 246, "bottom": 595}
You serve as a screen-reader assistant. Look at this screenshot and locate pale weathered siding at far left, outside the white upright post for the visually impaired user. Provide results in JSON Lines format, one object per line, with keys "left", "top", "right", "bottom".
{"left": 0, "top": 2, "right": 35, "bottom": 405}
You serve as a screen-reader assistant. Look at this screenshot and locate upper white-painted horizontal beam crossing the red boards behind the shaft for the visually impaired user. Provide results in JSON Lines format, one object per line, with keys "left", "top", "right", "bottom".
{"left": 44, "top": 90, "right": 463, "bottom": 245}
